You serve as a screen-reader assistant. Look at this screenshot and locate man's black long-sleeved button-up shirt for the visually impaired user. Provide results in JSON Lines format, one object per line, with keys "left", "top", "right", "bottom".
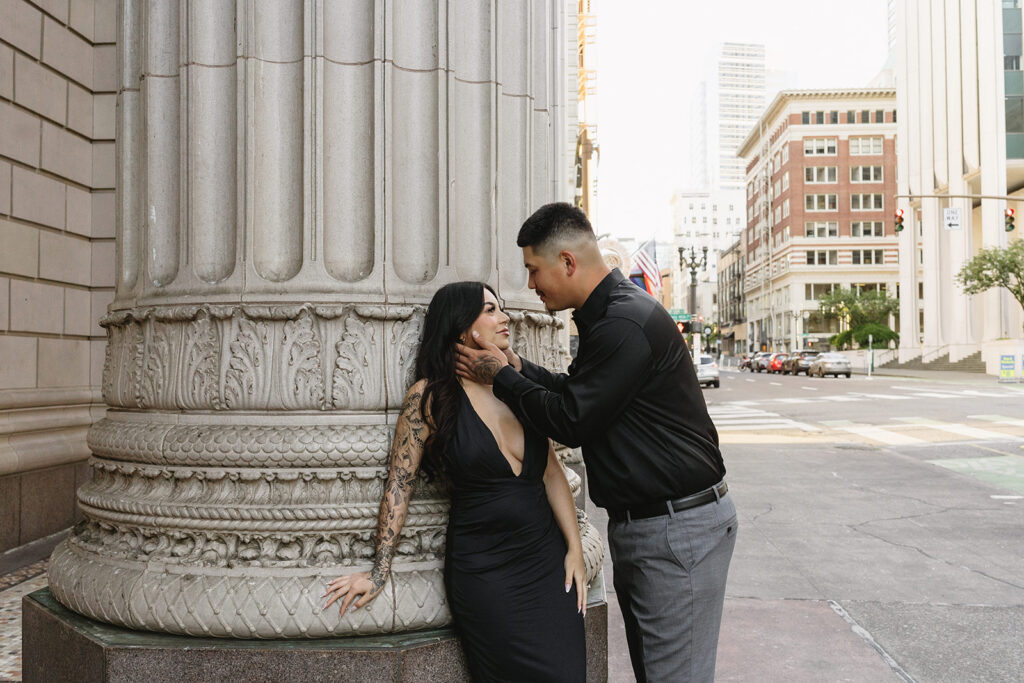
{"left": 495, "top": 269, "right": 725, "bottom": 510}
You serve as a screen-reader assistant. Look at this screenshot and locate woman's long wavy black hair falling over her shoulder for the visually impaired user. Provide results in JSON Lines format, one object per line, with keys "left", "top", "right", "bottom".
{"left": 416, "top": 282, "right": 498, "bottom": 490}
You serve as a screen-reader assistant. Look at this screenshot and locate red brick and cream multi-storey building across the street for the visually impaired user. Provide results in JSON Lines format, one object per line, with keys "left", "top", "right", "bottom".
{"left": 737, "top": 88, "right": 899, "bottom": 350}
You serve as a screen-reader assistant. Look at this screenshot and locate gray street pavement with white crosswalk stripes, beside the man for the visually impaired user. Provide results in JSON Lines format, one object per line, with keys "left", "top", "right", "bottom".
{"left": 591, "top": 371, "right": 1024, "bottom": 683}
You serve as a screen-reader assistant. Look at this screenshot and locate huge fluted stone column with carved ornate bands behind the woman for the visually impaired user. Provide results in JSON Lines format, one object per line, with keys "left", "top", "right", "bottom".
{"left": 50, "top": 0, "right": 602, "bottom": 638}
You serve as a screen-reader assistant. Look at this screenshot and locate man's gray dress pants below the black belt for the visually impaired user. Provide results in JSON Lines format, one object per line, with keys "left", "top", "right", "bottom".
{"left": 608, "top": 494, "right": 737, "bottom": 683}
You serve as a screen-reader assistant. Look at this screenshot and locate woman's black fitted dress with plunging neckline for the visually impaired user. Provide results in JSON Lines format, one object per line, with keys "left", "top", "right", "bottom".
{"left": 444, "top": 392, "right": 586, "bottom": 683}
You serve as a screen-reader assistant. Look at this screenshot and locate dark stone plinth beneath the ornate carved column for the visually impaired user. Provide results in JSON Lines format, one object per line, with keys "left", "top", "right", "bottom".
{"left": 22, "top": 589, "right": 608, "bottom": 683}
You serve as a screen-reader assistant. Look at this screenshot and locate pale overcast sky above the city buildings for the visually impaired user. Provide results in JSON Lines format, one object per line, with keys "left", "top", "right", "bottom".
{"left": 597, "top": 0, "right": 888, "bottom": 244}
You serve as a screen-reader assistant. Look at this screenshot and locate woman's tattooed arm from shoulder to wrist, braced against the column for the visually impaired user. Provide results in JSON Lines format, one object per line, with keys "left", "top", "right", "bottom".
{"left": 370, "top": 387, "right": 428, "bottom": 592}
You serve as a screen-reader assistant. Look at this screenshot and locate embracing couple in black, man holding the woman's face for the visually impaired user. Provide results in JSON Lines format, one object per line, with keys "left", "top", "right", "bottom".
{"left": 325, "top": 204, "right": 737, "bottom": 682}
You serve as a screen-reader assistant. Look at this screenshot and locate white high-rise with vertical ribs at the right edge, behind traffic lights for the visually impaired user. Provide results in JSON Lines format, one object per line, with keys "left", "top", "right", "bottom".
{"left": 894, "top": 0, "right": 1024, "bottom": 374}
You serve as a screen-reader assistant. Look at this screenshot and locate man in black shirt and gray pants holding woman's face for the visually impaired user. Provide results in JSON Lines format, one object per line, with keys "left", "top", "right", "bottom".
{"left": 458, "top": 204, "right": 737, "bottom": 682}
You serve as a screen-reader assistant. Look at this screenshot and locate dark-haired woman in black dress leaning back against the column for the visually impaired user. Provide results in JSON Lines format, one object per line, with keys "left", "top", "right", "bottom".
{"left": 324, "top": 283, "right": 587, "bottom": 682}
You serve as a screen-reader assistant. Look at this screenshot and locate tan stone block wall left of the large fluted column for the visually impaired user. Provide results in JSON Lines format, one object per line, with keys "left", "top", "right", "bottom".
{"left": 0, "top": 0, "right": 117, "bottom": 552}
